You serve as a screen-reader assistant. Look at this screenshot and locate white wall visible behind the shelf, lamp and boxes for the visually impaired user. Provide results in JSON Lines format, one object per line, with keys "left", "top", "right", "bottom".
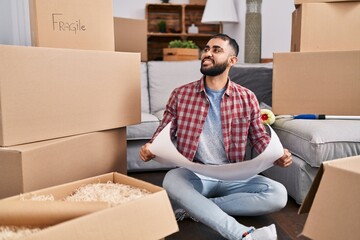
{"left": 0, "top": 0, "right": 295, "bottom": 62}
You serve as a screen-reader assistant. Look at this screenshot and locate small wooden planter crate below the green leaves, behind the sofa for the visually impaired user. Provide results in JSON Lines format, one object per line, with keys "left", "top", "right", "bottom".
{"left": 163, "top": 48, "right": 199, "bottom": 61}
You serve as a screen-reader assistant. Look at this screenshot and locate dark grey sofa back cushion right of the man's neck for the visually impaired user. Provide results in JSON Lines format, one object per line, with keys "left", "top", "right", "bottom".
{"left": 229, "top": 64, "right": 272, "bottom": 106}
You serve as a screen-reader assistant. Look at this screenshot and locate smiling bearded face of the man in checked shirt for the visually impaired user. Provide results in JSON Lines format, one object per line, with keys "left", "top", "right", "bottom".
{"left": 200, "top": 38, "right": 232, "bottom": 76}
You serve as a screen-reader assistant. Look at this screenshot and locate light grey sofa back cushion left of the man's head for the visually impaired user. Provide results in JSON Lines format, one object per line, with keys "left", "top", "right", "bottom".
{"left": 148, "top": 60, "right": 202, "bottom": 113}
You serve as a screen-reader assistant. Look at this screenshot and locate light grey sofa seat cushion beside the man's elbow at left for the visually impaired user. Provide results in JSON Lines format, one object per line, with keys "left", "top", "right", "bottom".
{"left": 126, "top": 112, "right": 159, "bottom": 140}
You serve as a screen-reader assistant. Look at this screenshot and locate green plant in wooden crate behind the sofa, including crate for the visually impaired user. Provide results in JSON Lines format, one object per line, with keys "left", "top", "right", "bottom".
{"left": 163, "top": 40, "right": 199, "bottom": 61}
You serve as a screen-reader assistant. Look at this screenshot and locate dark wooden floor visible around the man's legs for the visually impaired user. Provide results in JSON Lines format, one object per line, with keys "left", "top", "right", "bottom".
{"left": 128, "top": 171, "right": 307, "bottom": 240}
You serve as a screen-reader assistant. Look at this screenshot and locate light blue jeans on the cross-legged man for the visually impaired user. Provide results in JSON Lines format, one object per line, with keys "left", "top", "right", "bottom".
{"left": 163, "top": 168, "right": 287, "bottom": 240}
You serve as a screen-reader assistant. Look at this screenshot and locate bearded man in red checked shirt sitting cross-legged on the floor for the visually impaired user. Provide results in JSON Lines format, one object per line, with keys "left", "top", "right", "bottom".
{"left": 139, "top": 34, "right": 292, "bottom": 240}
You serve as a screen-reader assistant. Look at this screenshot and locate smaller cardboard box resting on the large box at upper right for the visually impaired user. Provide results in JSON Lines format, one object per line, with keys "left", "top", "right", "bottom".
{"left": 291, "top": 2, "right": 360, "bottom": 52}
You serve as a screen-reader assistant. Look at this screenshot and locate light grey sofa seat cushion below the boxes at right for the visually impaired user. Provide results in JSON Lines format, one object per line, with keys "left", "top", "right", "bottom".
{"left": 272, "top": 119, "right": 360, "bottom": 167}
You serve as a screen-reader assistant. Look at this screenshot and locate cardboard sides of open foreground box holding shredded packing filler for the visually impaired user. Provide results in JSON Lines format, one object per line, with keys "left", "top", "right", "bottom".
{"left": 0, "top": 173, "right": 179, "bottom": 240}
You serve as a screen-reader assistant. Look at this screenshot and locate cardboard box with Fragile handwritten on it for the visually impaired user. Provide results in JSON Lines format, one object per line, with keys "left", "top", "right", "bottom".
{"left": 29, "top": 0, "right": 114, "bottom": 51}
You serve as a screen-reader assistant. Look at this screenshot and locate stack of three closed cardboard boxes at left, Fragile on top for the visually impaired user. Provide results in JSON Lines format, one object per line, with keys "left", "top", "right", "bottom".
{"left": 0, "top": 0, "right": 140, "bottom": 198}
